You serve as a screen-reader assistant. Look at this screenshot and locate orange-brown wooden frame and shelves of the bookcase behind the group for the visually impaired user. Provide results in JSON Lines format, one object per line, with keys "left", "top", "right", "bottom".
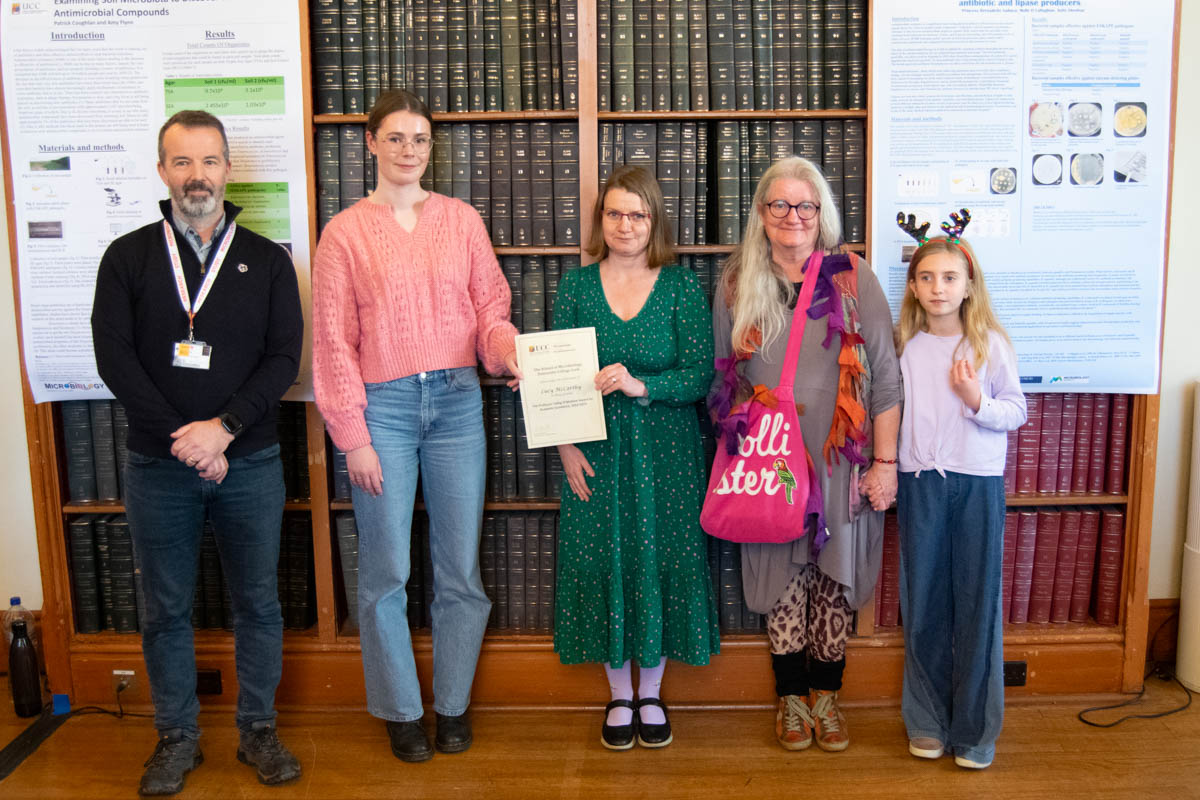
{"left": 7, "top": 0, "right": 1158, "bottom": 708}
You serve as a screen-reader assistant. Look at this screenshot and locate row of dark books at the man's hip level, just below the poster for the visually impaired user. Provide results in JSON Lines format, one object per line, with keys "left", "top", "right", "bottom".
{"left": 60, "top": 399, "right": 310, "bottom": 503}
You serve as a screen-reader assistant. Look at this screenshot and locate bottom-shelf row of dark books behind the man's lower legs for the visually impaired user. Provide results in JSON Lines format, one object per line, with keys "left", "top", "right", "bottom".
{"left": 67, "top": 513, "right": 317, "bottom": 633}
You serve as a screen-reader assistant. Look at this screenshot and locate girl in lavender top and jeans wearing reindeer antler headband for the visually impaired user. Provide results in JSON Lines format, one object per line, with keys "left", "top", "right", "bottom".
{"left": 896, "top": 209, "right": 1025, "bottom": 769}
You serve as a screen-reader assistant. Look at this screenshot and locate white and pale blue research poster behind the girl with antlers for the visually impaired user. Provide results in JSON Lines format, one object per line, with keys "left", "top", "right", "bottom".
{"left": 870, "top": 0, "right": 1175, "bottom": 393}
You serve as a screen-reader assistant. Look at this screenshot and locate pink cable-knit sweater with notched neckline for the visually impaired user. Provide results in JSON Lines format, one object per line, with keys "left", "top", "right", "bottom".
{"left": 312, "top": 193, "right": 517, "bottom": 451}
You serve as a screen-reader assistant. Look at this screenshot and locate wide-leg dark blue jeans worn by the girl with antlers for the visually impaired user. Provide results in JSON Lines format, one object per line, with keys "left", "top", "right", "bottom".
{"left": 898, "top": 470, "right": 1004, "bottom": 764}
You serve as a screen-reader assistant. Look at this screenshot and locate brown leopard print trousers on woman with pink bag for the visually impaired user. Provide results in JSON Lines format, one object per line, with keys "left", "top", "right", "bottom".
{"left": 767, "top": 564, "right": 854, "bottom": 661}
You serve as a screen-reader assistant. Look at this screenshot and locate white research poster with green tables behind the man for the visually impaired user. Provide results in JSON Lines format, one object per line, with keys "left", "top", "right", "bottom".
{"left": 0, "top": 0, "right": 312, "bottom": 402}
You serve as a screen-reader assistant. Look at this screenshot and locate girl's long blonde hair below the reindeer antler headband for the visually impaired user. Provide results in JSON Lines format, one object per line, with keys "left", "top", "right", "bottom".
{"left": 896, "top": 236, "right": 1012, "bottom": 368}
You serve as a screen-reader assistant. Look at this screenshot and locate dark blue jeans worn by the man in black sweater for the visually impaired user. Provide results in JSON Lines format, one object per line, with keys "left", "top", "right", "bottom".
{"left": 125, "top": 445, "right": 284, "bottom": 739}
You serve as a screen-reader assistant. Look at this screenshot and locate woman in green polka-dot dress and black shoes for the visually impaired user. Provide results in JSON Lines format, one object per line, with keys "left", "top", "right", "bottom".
{"left": 554, "top": 167, "right": 720, "bottom": 750}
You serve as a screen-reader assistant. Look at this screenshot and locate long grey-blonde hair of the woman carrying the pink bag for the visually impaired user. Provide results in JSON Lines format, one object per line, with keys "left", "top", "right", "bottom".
{"left": 721, "top": 156, "right": 841, "bottom": 354}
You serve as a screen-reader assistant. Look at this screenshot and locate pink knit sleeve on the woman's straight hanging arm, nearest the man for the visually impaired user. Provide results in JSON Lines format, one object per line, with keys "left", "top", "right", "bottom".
{"left": 312, "top": 219, "right": 371, "bottom": 452}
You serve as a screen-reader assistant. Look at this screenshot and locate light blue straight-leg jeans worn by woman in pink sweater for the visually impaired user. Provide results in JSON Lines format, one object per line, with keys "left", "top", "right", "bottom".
{"left": 353, "top": 367, "right": 492, "bottom": 722}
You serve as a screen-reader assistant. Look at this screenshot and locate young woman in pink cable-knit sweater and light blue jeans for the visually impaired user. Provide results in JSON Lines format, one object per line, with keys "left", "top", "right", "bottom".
{"left": 312, "top": 91, "right": 517, "bottom": 762}
